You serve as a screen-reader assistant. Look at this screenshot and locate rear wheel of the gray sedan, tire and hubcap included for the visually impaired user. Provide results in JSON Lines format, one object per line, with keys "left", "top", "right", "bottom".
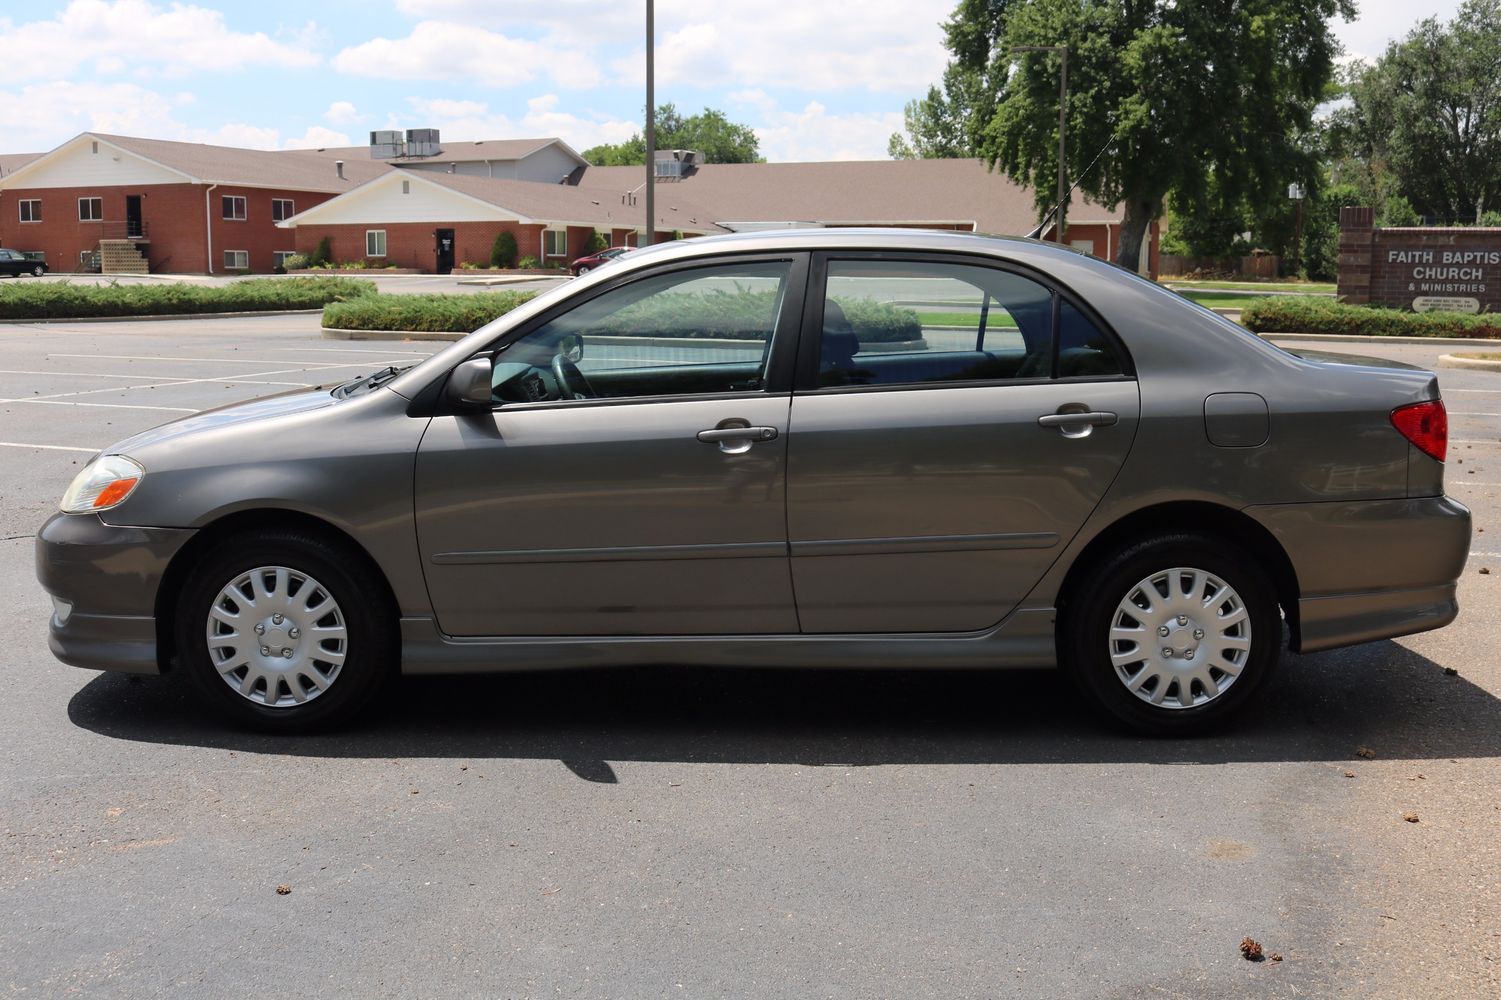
{"left": 1060, "top": 533, "right": 1282, "bottom": 736}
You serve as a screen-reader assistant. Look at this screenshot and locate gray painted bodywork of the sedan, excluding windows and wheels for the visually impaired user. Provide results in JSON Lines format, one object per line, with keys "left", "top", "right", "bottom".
{"left": 38, "top": 230, "right": 1469, "bottom": 673}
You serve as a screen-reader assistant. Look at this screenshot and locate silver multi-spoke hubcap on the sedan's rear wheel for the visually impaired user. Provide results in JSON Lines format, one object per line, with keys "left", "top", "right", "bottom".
{"left": 1109, "top": 566, "right": 1250, "bottom": 709}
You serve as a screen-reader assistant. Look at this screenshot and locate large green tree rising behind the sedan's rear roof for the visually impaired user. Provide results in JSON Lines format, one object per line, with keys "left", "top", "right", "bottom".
{"left": 918, "top": 0, "right": 1354, "bottom": 269}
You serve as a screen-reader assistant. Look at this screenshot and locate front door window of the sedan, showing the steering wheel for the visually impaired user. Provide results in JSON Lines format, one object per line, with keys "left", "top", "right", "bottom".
{"left": 492, "top": 261, "right": 791, "bottom": 402}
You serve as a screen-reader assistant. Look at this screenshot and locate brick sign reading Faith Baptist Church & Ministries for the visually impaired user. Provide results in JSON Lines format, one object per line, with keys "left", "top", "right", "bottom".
{"left": 1339, "top": 207, "right": 1501, "bottom": 312}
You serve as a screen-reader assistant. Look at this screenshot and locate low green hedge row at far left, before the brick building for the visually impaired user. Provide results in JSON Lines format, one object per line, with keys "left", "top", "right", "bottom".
{"left": 0, "top": 278, "right": 375, "bottom": 320}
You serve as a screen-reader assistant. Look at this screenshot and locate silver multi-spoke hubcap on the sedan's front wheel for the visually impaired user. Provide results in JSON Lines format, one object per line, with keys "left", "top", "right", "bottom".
{"left": 207, "top": 566, "right": 350, "bottom": 709}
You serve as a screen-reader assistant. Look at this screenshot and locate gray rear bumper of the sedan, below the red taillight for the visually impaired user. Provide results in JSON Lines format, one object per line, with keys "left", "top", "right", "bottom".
{"left": 1246, "top": 497, "right": 1469, "bottom": 653}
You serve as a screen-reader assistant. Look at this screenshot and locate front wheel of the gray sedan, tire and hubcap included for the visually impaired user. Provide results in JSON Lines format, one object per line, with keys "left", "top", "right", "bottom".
{"left": 177, "top": 532, "right": 399, "bottom": 731}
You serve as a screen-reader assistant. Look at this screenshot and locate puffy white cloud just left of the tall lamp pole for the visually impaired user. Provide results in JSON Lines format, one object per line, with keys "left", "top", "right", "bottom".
{"left": 333, "top": 21, "right": 599, "bottom": 89}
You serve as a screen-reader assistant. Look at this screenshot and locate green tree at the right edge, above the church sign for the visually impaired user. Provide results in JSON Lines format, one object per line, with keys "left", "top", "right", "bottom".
{"left": 1333, "top": 0, "right": 1501, "bottom": 221}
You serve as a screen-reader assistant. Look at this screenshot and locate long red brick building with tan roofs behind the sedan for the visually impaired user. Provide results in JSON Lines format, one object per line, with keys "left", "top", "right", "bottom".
{"left": 0, "top": 131, "right": 1157, "bottom": 275}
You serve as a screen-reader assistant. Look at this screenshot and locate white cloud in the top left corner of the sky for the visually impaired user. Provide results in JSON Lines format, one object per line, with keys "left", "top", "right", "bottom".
{"left": 0, "top": 0, "right": 320, "bottom": 80}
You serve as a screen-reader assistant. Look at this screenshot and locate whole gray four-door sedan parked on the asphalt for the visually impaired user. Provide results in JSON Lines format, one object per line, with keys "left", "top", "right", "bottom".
{"left": 38, "top": 230, "right": 1469, "bottom": 733}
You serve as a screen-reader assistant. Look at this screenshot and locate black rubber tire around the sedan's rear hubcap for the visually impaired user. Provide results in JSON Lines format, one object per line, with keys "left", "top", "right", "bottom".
{"left": 1058, "top": 532, "right": 1282, "bottom": 736}
